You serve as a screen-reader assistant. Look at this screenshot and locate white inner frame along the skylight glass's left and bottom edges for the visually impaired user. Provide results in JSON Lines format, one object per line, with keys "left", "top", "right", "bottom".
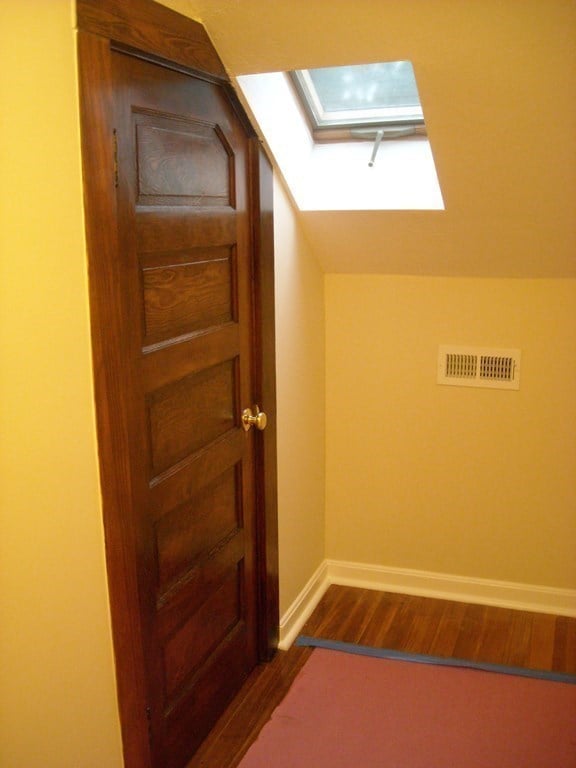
{"left": 289, "top": 62, "right": 424, "bottom": 134}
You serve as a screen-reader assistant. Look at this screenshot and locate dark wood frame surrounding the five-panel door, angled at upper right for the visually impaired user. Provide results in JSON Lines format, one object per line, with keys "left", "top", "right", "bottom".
{"left": 76, "top": 0, "right": 279, "bottom": 768}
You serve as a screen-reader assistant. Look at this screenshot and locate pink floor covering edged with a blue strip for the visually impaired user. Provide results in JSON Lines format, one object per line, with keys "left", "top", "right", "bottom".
{"left": 239, "top": 648, "right": 576, "bottom": 768}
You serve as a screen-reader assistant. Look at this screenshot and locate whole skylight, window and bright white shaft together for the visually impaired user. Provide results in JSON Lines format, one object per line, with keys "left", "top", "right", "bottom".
{"left": 236, "top": 62, "right": 444, "bottom": 211}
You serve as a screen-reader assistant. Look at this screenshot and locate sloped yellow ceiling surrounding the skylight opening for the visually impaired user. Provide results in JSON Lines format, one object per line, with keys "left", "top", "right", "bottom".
{"left": 163, "top": 0, "right": 576, "bottom": 278}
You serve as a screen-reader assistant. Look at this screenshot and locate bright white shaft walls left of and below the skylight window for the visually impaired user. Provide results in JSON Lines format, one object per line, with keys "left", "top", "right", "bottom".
{"left": 237, "top": 72, "right": 444, "bottom": 211}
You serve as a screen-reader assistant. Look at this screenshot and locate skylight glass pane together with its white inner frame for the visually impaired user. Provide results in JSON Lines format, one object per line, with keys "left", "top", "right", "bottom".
{"left": 292, "top": 61, "right": 424, "bottom": 128}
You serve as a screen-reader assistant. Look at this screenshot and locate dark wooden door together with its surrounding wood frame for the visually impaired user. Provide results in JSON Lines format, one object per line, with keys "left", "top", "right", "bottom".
{"left": 79, "top": 0, "right": 277, "bottom": 768}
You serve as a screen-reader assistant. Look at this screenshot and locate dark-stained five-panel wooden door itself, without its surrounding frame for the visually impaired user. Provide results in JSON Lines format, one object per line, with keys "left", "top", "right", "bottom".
{"left": 112, "top": 52, "right": 258, "bottom": 768}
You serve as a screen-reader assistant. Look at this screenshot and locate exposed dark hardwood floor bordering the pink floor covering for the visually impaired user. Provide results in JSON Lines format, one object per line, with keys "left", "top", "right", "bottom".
{"left": 188, "top": 586, "right": 576, "bottom": 768}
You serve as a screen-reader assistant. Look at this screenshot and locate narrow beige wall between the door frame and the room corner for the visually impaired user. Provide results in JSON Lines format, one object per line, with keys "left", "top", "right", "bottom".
{"left": 274, "top": 181, "right": 325, "bottom": 614}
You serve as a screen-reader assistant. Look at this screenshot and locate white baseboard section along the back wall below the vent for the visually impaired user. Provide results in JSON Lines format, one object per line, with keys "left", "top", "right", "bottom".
{"left": 326, "top": 560, "right": 576, "bottom": 616}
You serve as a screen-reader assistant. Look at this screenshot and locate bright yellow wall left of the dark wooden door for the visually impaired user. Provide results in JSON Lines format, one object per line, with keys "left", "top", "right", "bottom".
{"left": 0, "top": 0, "right": 121, "bottom": 768}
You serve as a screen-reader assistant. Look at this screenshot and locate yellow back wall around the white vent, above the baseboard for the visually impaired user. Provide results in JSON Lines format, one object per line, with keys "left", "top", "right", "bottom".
{"left": 326, "top": 275, "right": 576, "bottom": 589}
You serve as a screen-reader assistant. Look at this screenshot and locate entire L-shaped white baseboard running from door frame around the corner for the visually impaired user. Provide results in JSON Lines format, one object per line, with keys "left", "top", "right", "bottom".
{"left": 278, "top": 560, "right": 576, "bottom": 651}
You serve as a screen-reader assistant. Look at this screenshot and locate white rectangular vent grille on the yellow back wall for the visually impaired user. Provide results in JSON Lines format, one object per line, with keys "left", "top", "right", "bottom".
{"left": 437, "top": 345, "right": 520, "bottom": 389}
